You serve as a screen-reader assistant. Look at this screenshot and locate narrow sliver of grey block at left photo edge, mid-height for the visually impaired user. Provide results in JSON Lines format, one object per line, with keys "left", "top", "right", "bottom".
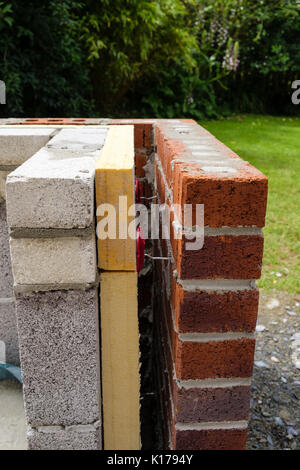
{"left": 0, "top": 203, "right": 13, "bottom": 298}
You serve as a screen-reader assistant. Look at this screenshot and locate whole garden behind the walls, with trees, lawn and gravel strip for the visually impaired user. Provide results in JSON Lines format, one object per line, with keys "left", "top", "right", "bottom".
{"left": 0, "top": 0, "right": 300, "bottom": 449}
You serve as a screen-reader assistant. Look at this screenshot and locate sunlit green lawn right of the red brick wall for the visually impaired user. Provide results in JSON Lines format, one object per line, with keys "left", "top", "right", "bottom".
{"left": 200, "top": 115, "right": 300, "bottom": 292}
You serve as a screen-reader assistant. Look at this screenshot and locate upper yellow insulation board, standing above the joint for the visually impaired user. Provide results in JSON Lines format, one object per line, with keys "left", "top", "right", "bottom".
{"left": 96, "top": 126, "right": 136, "bottom": 271}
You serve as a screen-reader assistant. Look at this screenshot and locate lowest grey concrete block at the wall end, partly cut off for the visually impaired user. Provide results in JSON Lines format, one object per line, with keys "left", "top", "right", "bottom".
{"left": 27, "top": 426, "right": 102, "bottom": 450}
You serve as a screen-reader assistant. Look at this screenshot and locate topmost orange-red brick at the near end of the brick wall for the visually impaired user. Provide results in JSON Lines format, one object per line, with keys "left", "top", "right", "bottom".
{"left": 173, "top": 163, "right": 268, "bottom": 227}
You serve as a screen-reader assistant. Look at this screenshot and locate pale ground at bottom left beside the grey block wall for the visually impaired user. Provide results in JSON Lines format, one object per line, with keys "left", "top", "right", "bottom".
{"left": 0, "top": 380, "right": 27, "bottom": 450}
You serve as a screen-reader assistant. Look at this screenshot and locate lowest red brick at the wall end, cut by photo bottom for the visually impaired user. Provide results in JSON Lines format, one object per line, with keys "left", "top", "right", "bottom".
{"left": 172, "top": 428, "right": 247, "bottom": 450}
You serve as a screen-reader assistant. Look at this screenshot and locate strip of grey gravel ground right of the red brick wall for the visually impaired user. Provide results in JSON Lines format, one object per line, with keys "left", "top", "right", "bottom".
{"left": 247, "top": 290, "right": 300, "bottom": 450}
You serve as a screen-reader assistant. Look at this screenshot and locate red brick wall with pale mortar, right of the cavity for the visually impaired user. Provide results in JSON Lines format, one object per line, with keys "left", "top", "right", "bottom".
{"left": 153, "top": 121, "right": 267, "bottom": 450}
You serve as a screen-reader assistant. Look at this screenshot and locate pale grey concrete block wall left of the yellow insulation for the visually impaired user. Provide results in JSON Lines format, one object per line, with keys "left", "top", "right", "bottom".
{"left": 6, "top": 127, "right": 107, "bottom": 450}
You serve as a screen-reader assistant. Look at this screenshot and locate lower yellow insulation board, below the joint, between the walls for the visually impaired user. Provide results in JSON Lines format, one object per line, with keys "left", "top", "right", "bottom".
{"left": 100, "top": 272, "right": 140, "bottom": 450}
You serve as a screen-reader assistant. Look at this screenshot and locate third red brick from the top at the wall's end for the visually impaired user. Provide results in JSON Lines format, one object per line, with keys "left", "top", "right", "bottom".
{"left": 172, "top": 279, "right": 259, "bottom": 333}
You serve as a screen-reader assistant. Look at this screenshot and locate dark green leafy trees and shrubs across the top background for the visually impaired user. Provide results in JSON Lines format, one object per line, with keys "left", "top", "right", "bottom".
{"left": 0, "top": 0, "right": 300, "bottom": 119}
